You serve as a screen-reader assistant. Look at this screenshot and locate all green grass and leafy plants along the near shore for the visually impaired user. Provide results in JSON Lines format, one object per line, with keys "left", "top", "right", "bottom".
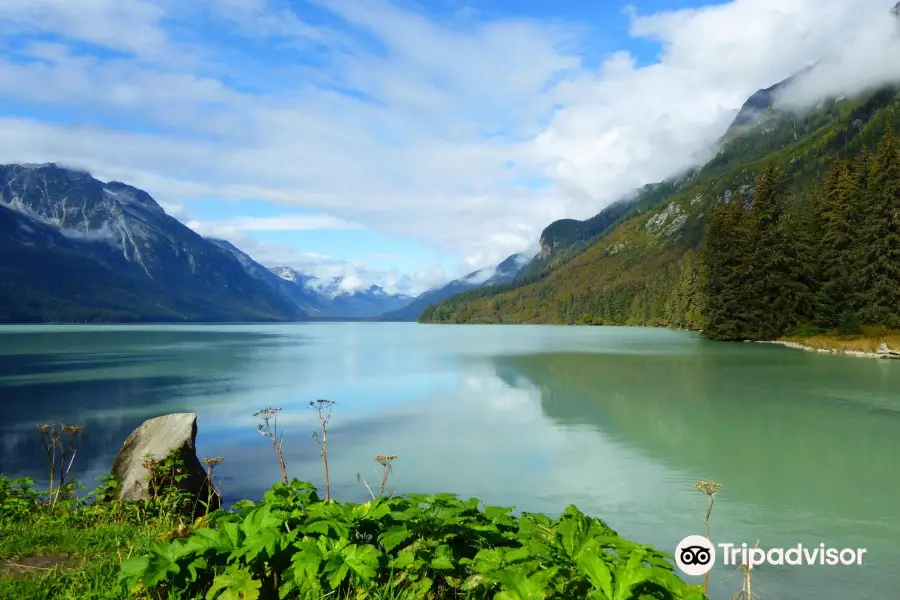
{"left": 0, "top": 476, "right": 705, "bottom": 600}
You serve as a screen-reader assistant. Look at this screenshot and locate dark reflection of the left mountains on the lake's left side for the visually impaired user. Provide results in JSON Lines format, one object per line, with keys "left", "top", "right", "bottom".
{"left": 0, "top": 329, "right": 296, "bottom": 482}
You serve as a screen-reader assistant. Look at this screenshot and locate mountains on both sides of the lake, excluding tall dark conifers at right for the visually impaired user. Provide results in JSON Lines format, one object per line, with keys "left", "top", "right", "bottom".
{"left": 0, "top": 3, "right": 900, "bottom": 326}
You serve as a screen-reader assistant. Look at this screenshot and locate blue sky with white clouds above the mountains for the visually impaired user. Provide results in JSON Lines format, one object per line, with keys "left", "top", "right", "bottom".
{"left": 0, "top": 0, "right": 889, "bottom": 293}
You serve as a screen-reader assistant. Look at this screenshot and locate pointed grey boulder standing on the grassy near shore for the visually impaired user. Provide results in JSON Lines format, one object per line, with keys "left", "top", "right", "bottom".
{"left": 112, "top": 413, "right": 221, "bottom": 510}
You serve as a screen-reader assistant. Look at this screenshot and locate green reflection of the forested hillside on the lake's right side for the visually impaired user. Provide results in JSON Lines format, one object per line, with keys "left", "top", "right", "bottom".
{"left": 496, "top": 347, "right": 900, "bottom": 598}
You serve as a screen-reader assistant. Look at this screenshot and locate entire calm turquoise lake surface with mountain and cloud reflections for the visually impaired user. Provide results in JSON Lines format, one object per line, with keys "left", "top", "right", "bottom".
{"left": 0, "top": 323, "right": 900, "bottom": 600}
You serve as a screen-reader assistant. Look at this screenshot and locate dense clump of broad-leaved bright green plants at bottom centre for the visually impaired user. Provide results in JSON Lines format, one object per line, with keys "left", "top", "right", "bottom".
{"left": 122, "top": 479, "right": 703, "bottom": 600}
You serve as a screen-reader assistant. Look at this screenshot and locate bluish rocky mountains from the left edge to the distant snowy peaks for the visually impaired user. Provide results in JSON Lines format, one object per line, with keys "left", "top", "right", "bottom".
{"left": 0, "top": 163, "right": 523, "bottom": 322}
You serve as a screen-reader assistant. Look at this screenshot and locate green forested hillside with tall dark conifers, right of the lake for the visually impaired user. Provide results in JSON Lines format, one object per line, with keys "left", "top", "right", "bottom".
{"left": 420, "top": 88, "right": 900, "bottom": 339}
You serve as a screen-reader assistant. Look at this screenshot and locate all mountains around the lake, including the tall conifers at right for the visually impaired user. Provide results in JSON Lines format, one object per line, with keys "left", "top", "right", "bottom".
{"left": 0, "top": 21, "right": 900, "bottom": 350}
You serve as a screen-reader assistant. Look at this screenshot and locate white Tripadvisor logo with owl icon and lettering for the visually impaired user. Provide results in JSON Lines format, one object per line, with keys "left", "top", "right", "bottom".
{"left": 675, "top": 535, "right": 866, "bottom": 575}
